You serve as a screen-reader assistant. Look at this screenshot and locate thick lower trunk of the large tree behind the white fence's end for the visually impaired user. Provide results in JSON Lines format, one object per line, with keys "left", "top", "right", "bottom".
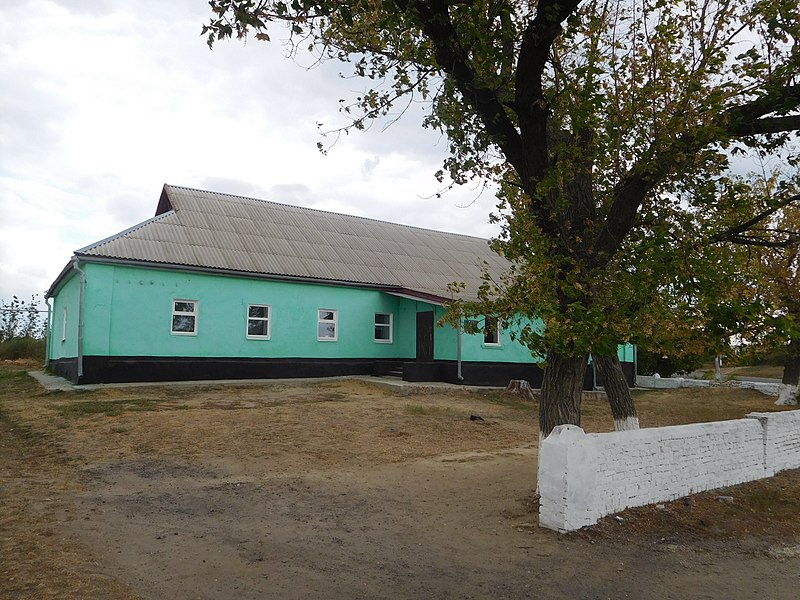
{"left": 539, "top": 350, "right": 587, "bottom": 441}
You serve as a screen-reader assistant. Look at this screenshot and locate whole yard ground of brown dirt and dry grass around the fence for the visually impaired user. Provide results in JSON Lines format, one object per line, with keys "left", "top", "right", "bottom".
{"left": 0, "top": 365, "right": 800, "bottom": 600}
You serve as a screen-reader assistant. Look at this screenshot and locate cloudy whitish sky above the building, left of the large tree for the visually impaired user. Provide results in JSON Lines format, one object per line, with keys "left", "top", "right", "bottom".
{"left": 0, "top": 0, "right": 496, "bottom": 300}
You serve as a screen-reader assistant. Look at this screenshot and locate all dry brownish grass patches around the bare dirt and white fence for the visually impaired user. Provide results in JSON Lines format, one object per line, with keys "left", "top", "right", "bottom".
{"left": 0, "top": 364, "right": 800, "bottom": 599}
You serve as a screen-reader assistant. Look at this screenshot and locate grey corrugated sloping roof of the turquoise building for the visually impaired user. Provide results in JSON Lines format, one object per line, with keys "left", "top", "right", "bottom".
{"left": 76, "top": 185, "right": 508, "bottom": 298}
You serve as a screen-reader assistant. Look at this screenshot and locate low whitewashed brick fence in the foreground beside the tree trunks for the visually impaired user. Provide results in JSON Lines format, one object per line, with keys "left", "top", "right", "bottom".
{"left": 539, "top": 410, "right": 800, "bottom": 531}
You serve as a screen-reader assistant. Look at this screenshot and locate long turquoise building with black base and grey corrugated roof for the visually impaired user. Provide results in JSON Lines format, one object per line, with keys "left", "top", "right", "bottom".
{"left": 46, "top": 185, "right": 634, "bottom": 386}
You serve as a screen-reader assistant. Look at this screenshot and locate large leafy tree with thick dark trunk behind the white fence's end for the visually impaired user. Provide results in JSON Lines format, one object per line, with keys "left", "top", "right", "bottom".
{"left": 204, "top": 0, "right": 800, "bottom": 434}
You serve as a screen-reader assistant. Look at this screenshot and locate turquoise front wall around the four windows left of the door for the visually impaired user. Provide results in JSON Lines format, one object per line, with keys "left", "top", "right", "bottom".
{"left": 84, "top": 264, "right": 416, "bottom": 359}
